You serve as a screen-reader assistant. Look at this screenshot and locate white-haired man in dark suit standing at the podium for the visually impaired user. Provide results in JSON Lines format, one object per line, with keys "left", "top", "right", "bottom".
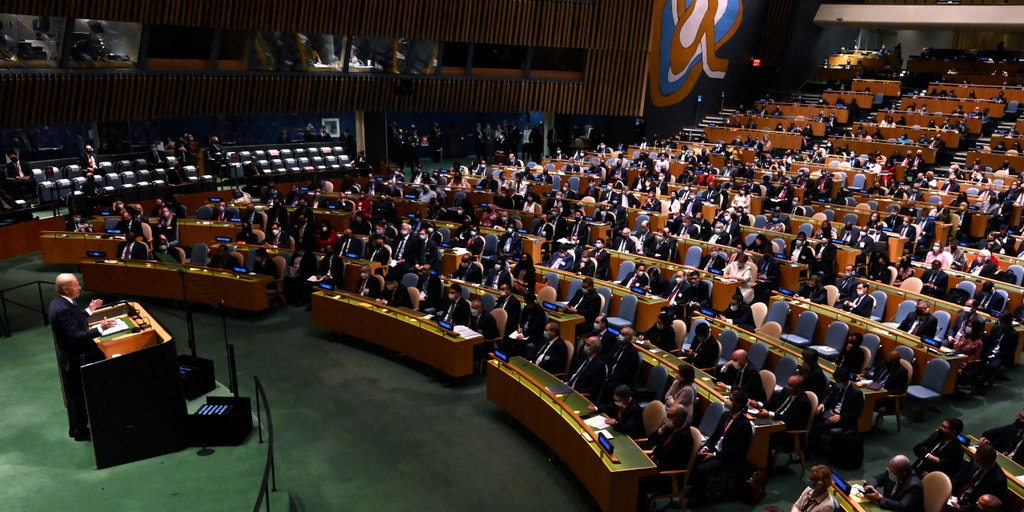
{"left": 49, "top": 273, "right": 114, "bottom": 441}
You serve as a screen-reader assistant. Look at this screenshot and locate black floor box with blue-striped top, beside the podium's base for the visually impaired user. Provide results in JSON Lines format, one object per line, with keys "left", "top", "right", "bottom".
{"left": 185, "top": 396, "right": 253, "bottom": 446}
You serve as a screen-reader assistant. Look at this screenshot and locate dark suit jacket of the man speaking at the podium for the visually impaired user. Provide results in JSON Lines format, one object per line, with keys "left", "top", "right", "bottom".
{"left": 49, "top": 297, "right": 103, "bottom": 372}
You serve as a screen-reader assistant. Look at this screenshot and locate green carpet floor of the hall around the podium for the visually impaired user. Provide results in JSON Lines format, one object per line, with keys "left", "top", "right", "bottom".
{"left": 0, "top": 253, "right": 1022, "bottom": 512}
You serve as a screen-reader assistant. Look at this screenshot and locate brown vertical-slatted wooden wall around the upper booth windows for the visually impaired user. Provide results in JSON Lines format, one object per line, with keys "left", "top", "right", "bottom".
{"left": 0, "top": 0, "right": 653, "bottom": 122}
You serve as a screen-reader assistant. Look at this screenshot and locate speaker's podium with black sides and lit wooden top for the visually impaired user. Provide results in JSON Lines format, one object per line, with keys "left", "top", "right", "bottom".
{"left": 82, "top": 302, "right": 188, "bottom": 469}
